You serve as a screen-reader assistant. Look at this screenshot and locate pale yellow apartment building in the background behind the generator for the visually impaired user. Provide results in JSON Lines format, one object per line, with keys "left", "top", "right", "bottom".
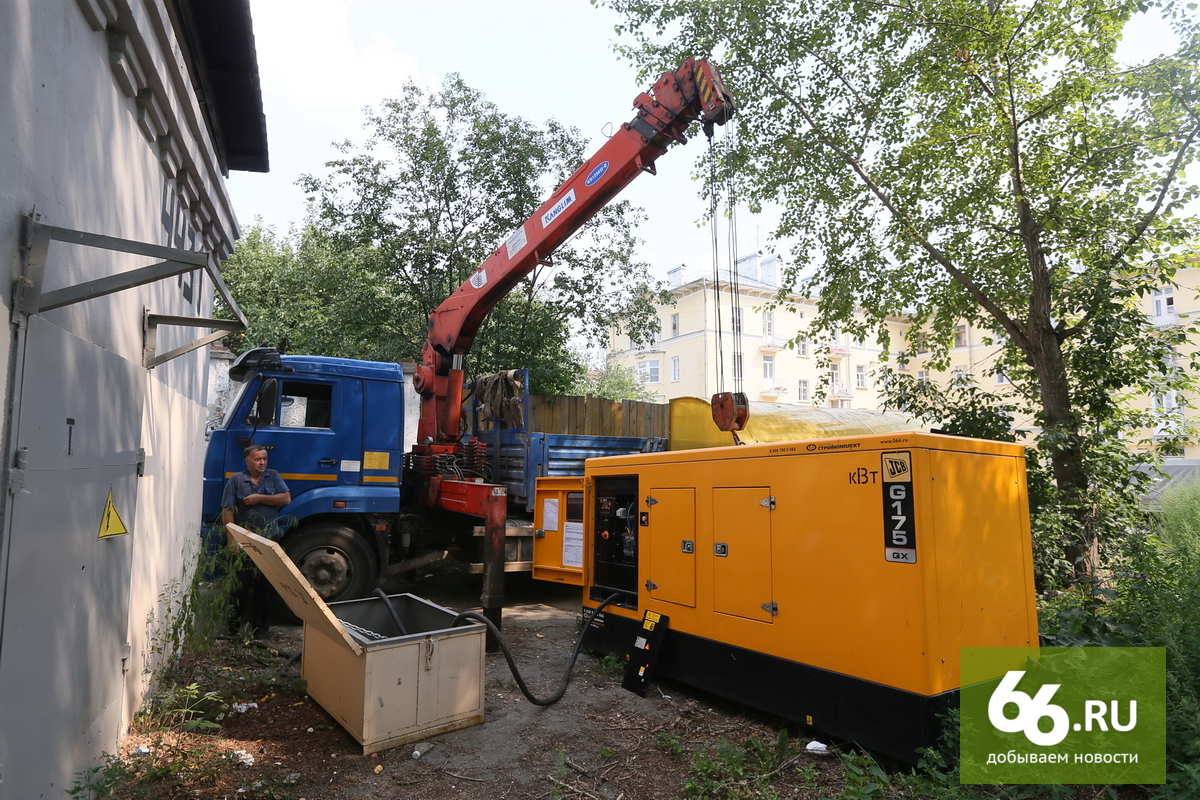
{"left": 612, "top": 253, "right": 1200, "bottom": 458}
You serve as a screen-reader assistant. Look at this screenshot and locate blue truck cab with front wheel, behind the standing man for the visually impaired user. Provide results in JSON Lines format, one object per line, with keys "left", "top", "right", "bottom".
{"left": 203, "top": 348, "right": 406, "bottom": 600}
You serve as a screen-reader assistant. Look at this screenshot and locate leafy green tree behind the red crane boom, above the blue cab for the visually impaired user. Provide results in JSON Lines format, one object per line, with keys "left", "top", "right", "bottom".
{"left": 218, "top": 76, "right": 658, "bottom": 393}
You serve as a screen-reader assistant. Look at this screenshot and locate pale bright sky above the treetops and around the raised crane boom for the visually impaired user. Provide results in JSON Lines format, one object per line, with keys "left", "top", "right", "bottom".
{"left": 228, "top": 0, "right": 768, "bottom": 286}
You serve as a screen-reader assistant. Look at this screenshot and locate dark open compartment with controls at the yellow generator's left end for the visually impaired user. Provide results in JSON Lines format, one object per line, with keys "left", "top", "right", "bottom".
{"left": 590, "top": 475, "right": 638, "bottom": 608}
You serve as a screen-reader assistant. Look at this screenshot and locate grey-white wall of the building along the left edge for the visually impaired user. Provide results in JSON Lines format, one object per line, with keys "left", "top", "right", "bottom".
{"left": 0, "top": 0, "right": 246, "bottom": 800}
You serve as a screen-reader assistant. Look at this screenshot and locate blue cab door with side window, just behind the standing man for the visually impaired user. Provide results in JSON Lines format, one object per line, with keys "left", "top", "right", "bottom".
{"left": 226, "top": 377, "right": 362, "bottom": 503}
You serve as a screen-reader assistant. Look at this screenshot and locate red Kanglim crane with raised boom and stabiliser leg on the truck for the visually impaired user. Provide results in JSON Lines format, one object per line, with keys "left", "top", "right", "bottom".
{"left": 408, "top": 59, "right": 734, "bottom": 624}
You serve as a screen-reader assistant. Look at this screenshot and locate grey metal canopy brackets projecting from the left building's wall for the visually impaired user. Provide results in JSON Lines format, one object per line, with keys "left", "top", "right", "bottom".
{"left": 13, "top": 215, "right": 247, "bottom": 369}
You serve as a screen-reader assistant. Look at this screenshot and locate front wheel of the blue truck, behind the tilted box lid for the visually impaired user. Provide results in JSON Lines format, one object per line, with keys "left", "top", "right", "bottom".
{"left": 283, "top": 523, "right": 379, "bottom": 602}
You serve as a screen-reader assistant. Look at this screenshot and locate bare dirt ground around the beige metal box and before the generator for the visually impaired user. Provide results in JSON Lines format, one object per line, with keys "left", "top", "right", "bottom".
{"left": 114, "top": 569, "right": 1161, "bottom": 800}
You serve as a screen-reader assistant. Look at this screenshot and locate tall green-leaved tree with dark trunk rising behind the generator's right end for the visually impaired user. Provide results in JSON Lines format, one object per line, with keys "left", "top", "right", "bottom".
{"left": 606, "top": 0, "right": 1200, "bottom": 575}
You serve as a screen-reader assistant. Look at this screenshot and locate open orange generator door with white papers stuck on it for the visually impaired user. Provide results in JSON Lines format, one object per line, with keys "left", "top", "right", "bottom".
{"left": 533, "top": 475, "right": 583, "bottom": 587}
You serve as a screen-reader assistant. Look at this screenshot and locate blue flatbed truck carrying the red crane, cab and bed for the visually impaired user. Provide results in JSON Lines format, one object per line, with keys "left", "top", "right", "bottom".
{"left": 204, "top": 348, "right": 666, "bottom": 601}
